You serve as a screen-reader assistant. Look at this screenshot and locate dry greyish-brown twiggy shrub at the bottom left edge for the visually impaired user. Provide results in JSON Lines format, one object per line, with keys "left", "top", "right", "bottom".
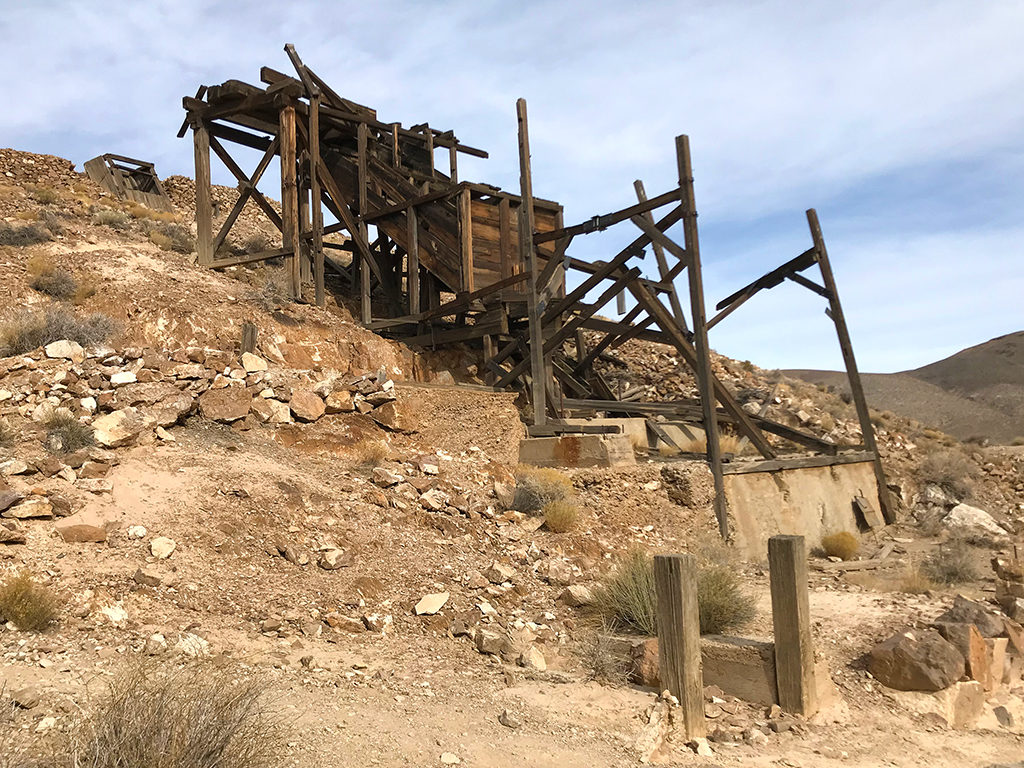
{"left": 68, "top": 662, "right": 285, "bottom": 768}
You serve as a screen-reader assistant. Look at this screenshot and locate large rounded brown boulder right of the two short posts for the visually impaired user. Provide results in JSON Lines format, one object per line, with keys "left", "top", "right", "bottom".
{"left": 867, "top": 630, "right": 966, "bottom": 691}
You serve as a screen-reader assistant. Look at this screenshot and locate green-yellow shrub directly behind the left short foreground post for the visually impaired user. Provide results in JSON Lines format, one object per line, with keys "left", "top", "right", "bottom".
{"left": 594, "top": 550, "right": 756, "bottom": 635}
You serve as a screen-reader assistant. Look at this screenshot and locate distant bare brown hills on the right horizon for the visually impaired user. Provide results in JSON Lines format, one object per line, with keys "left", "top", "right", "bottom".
{"left": 783, "top": 331, "right": 1024, "bottom": 443}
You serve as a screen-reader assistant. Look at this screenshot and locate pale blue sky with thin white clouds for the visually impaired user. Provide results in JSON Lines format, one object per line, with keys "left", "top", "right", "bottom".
{"left": 0, "top": 0, "right": 1024, "bottom": 372}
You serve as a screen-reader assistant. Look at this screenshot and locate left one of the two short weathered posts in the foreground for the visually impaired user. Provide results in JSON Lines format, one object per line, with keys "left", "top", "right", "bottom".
{"left": 654, "top": 554, "right": 707, "bottom": 739}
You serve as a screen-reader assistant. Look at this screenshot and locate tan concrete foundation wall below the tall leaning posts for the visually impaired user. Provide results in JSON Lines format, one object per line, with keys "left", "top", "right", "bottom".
{"left": 725, "top": 462, "right": 879, "bottom": 559}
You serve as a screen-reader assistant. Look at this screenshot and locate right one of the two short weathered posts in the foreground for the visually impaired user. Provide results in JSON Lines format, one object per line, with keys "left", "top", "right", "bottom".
{"left": 768, "top": 536, "right": 818, "bottom": 716}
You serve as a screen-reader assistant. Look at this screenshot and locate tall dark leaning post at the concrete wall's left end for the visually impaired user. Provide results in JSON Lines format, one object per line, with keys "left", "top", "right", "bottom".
{"left": 676, "top": 136, "right": 729, "bottom": 539}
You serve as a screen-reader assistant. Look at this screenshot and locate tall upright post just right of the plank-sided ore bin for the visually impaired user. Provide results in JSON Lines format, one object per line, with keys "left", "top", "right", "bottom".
{"left": 515, "top": 98, "right": 548, "bottom": 425}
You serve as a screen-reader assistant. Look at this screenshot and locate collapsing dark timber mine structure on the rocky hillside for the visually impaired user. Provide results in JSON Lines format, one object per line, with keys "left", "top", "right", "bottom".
{"left": 178, "top": 45, "right": 894, "bottom": 536}
